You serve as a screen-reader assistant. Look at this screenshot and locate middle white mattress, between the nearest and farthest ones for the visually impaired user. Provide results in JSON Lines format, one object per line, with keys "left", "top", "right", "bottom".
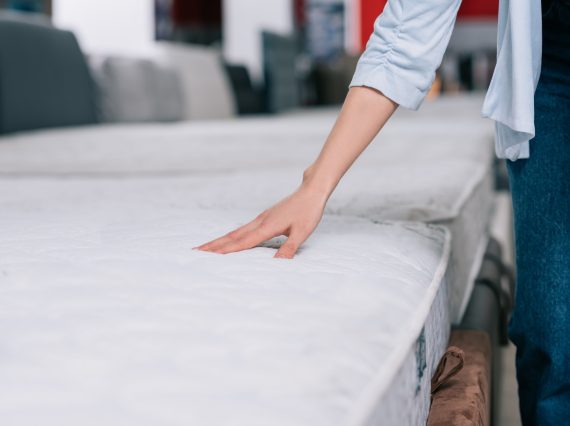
{"left": 18, "top": 154, "right": 488, "bottom": 323}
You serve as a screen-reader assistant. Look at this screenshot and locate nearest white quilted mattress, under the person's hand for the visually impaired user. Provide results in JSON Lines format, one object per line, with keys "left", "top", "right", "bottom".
{"left": 0, "top": 179, "right": 450, "bottom": 426}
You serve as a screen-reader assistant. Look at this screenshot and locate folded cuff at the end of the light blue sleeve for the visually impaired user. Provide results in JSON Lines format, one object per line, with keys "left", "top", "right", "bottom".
{"left": 349, "top": 61, "right": 427, "bottom": 111}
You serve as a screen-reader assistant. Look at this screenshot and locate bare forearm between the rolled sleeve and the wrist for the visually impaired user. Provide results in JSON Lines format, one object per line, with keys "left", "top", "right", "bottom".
{"left": 303, "top": 87, "right": 398, "bottom": 199}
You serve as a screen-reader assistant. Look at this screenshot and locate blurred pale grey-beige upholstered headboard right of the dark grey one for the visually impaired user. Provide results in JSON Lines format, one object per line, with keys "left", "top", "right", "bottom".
{"left": 90, "top": 42, "right": 235, "bottom": 122}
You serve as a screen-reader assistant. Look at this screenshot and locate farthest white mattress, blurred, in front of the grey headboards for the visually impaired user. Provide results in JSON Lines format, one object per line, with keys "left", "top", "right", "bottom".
{"left": 0, "top": 98, "right": 493, "bottom": 176}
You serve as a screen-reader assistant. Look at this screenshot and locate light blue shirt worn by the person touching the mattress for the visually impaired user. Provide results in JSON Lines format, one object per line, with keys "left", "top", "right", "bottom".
{"left": 350, "top": 0, "right": 542, "bottom": 161}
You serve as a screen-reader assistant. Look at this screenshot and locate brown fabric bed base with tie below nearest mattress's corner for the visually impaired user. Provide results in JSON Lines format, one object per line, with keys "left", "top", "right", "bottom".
{"left": 427, "top": 330, "right": 491, "bottom": 426}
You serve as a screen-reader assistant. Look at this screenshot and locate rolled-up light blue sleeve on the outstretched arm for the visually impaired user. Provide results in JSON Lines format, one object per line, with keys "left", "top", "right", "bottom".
{"left": 350, "top": 0, "right": 461, "bottom": 110}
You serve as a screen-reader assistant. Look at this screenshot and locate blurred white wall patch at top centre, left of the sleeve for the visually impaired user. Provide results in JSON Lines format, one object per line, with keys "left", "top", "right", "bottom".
{"left": 222, "top": 0, "right": 294, "bottom": 81}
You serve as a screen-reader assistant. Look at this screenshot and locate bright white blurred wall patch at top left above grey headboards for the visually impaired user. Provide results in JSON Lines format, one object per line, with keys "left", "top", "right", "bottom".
{"left": 53, "top": 0, "right": 154, "bottom": 55}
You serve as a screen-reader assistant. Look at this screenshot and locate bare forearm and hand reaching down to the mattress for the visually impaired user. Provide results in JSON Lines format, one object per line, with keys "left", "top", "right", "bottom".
{"left": 195, "top": 87, "right": 398, "bottom": 259}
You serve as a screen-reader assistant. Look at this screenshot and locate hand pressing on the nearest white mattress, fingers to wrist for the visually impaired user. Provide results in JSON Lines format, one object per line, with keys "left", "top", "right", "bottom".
{"left": 196, "top": 174, "right": 327, "bottom": 259}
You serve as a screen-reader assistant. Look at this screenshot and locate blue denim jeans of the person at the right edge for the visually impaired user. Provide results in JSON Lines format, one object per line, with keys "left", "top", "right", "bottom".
{"left": 508, "top": 0, "right": 570, "bottom": 426}
